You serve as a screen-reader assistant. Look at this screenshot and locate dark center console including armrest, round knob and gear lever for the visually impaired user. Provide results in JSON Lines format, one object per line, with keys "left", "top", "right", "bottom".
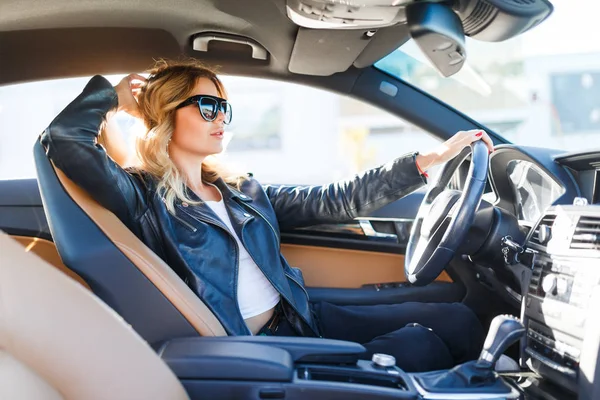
{"left": 158, "top": 316, "right": 525, "bottom": 400}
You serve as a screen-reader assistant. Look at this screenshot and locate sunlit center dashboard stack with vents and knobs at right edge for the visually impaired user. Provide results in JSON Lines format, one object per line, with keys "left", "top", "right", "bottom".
{"left": 521, "top": 206, "right": 600, "bottom": 400}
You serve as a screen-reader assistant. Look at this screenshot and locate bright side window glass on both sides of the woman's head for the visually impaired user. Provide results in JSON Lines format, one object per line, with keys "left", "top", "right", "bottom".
{"left": 0, "top": 76, "right": 440, "bottom": 184}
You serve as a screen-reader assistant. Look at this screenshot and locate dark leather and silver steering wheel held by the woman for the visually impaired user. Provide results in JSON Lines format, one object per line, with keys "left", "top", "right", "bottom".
{"left": 404, "top": 140, "right": 489, "bottom": 286}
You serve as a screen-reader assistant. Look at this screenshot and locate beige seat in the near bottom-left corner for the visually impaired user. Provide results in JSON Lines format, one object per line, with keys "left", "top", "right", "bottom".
{"left": 0, "top": 232, "right": 188, "bottom": 400}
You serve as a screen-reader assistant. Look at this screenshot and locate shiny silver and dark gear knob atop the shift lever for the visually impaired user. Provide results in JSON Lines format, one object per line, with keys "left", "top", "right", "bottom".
{"left": 477, "top": 315, "right": 525, "bottom": 368}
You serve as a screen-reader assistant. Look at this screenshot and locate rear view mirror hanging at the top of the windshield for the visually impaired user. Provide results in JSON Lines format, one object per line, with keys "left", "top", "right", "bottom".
{"left": 406, "top": 2, "right": 467, "bottom": 77}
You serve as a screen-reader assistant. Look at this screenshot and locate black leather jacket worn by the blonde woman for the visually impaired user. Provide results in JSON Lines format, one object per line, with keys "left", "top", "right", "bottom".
{"left": 41, "top": 76, "right": 426, "bottom": 336}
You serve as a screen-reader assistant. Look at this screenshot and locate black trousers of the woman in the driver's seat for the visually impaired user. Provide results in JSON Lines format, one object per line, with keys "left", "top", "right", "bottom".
{"left": 259, "top": 302, "right": 484, "bottom": 372}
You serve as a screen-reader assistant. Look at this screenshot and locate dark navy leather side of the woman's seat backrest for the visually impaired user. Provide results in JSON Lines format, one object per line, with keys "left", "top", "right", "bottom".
{"left": 34, "top": 138, "right": 216, "bottom": 344}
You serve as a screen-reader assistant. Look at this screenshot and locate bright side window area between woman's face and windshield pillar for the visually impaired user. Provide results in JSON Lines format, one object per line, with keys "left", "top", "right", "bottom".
{"left": 221, "top": 76, "right": 440, "bottom": 184}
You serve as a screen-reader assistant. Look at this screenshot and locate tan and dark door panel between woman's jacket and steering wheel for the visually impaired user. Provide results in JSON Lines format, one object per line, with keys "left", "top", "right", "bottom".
{"left": 281, "top": 191, "right": 465, "bottom": 304}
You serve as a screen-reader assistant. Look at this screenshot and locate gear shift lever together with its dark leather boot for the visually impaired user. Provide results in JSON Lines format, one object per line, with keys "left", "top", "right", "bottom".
{"left": 416, "top": 315, "right": 525, "bottom": 392}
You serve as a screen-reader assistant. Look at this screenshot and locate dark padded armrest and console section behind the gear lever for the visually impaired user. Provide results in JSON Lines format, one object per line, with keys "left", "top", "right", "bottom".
{"left": 159, "top": 336, "right": 419, "bottom": 400}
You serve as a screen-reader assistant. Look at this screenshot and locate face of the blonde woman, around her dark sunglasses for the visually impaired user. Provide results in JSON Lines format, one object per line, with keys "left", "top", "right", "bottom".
{"left": 169, "top": 78, "right": 225, "bottom": 157}
